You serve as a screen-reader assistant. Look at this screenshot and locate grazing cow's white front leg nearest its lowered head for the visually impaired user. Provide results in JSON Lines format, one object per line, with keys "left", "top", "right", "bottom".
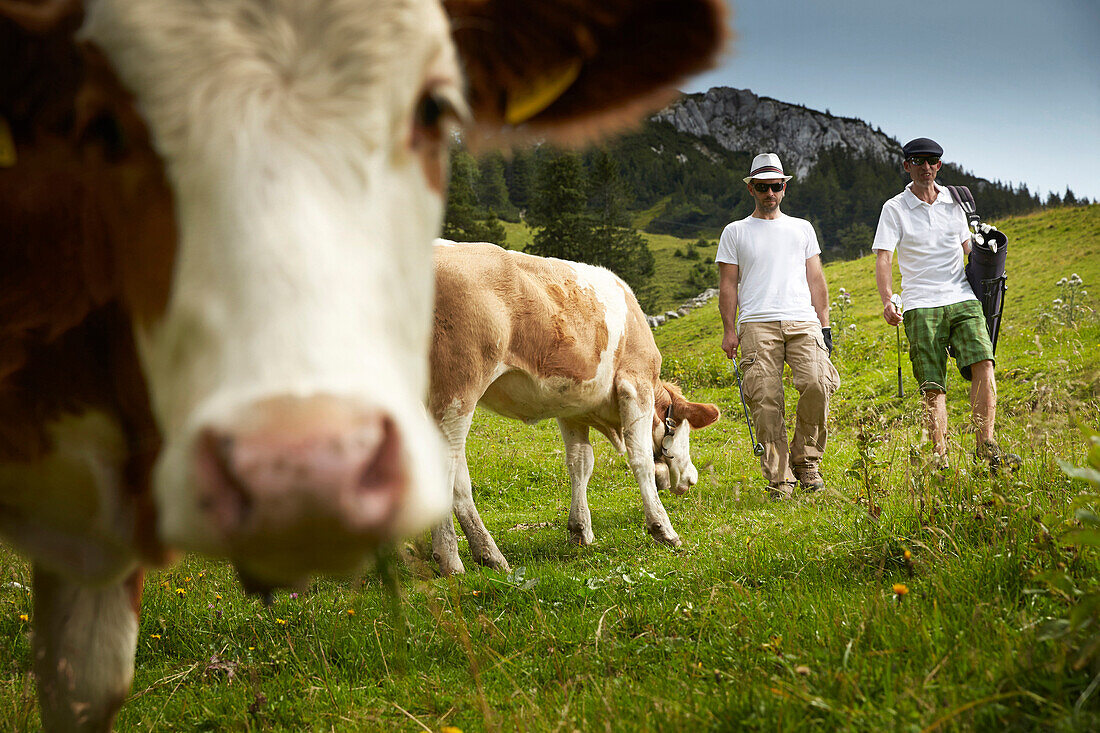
{"left": 617, "top": 382, "right": 682, "bottom": 547}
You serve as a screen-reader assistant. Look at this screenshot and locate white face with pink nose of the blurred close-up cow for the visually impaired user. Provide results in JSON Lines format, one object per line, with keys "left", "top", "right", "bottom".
{"left": 80, "top": 0, "right": 465, "bottom": 584}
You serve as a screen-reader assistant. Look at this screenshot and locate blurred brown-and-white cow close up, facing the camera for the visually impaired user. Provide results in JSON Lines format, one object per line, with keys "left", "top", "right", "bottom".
{"left": 0, "top": 0, "right": 724, "bottom": 731}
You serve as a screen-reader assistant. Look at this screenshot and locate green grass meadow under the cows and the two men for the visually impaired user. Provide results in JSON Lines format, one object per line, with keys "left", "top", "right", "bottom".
{"left": 0, "top": 206, "right": 1100, "bottom": 733}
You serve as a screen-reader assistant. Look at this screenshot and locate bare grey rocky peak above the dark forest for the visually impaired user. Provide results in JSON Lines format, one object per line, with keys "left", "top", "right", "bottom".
{"left": 653, "top": 87, "right": 901, "bottom": 177}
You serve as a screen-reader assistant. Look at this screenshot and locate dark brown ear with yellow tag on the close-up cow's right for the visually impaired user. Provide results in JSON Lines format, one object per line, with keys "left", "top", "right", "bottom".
{"left": 443, "top": 0, "right": 727, "bottom": 142}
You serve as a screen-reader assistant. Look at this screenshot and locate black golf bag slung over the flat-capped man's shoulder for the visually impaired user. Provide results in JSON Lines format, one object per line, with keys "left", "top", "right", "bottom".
{"left": 946, "top": 186, "right": 1009, "bottom": 381}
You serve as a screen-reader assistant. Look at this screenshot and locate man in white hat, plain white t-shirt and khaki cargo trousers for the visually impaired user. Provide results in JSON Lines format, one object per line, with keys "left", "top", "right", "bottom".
{"left": 715, "top": 153, "right": 840, "bottom": 499}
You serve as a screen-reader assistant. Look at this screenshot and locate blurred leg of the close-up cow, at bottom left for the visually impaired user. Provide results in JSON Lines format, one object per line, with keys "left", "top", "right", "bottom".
{"left": 33, "top": 565, "right": 143, "bottom": 732}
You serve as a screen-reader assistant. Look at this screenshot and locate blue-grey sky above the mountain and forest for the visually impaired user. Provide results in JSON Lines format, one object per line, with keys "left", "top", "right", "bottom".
{"left": 684, "top": 0, "right": 1100, "bottom": 200}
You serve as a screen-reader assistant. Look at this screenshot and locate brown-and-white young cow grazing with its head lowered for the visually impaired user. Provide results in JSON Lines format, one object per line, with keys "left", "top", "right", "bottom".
{"left": 429, "top": 240, "right": 718, "bottom": 575}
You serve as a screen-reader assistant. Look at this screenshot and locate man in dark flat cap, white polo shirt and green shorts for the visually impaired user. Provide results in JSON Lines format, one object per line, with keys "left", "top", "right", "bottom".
{"left": 871, "top": 138, "right": 1002, "bottom": 471}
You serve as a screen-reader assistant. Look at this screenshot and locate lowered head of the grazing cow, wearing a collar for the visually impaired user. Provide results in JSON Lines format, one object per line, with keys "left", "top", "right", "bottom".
{"left": 653, "top": 382, "right": 719, "bottom": 494}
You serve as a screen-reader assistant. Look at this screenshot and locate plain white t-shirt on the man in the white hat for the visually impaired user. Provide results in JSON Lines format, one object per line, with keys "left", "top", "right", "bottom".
{"left": 714, "top": 214, "right": 822, "bottom": 324}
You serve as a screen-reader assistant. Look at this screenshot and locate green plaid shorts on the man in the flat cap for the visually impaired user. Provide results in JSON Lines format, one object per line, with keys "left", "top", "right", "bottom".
{"left": 902, "top": 300, "right": 993, "bottom": 392}
